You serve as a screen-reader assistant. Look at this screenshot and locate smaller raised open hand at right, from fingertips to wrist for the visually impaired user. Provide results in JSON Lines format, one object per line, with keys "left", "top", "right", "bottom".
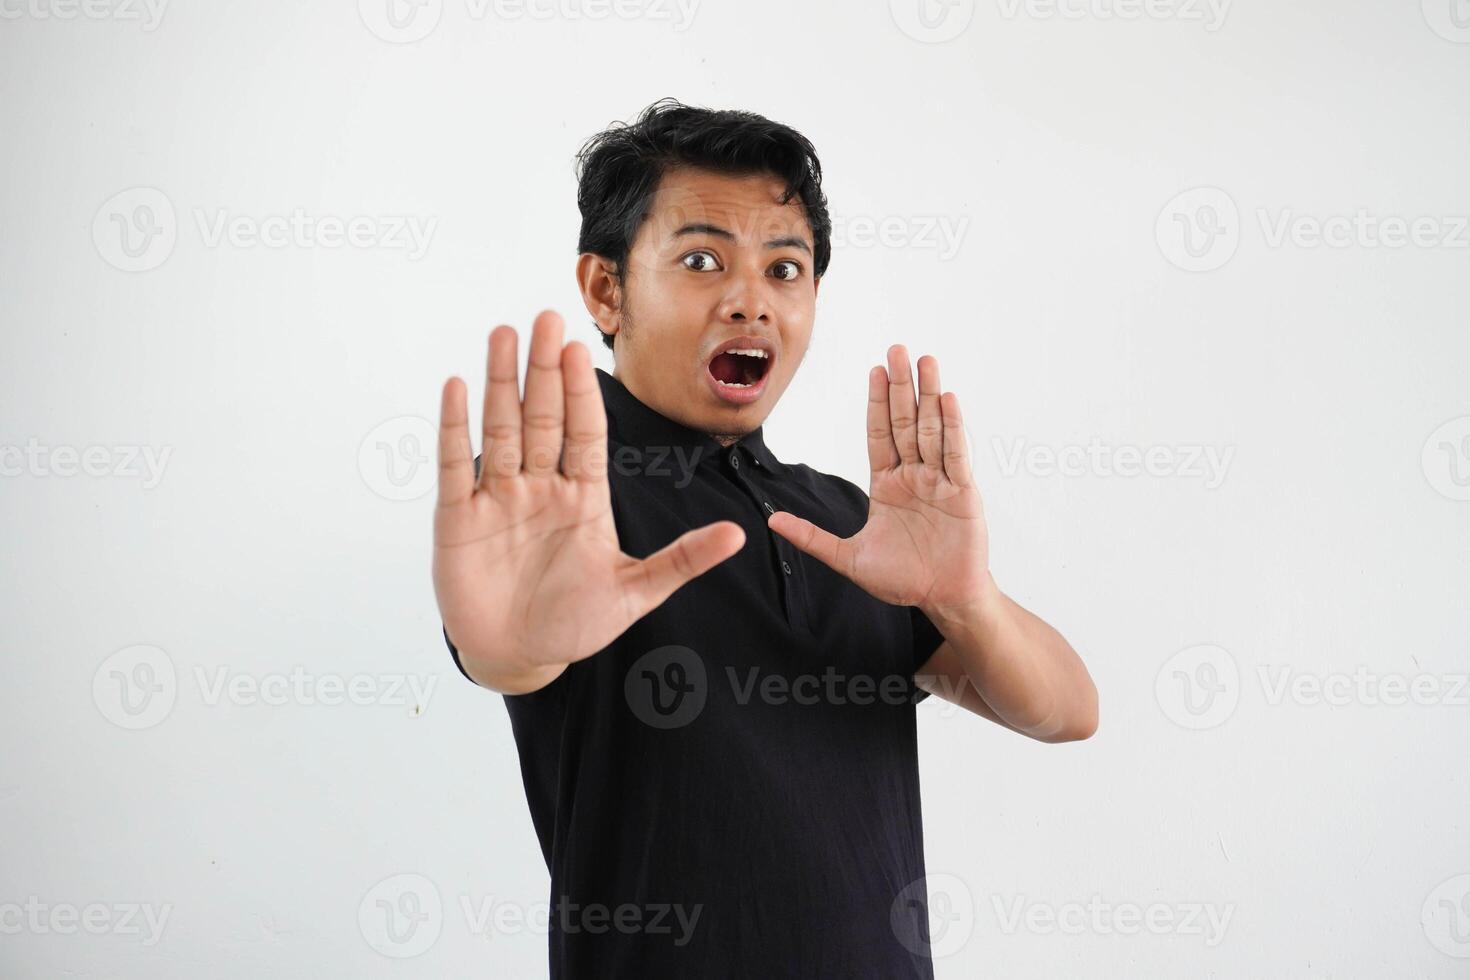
{"left": 769, "top": 345, "right": 995, "bottom": 619}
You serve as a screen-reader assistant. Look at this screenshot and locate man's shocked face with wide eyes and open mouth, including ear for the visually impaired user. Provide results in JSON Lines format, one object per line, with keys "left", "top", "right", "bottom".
{"left": 579, "top": 169, "right": 819, "bottom": 436}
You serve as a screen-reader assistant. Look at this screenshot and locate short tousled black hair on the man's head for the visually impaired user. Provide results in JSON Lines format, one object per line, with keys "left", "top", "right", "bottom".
{"left": 576, "top": 98, "right": 832, "bottom": 350}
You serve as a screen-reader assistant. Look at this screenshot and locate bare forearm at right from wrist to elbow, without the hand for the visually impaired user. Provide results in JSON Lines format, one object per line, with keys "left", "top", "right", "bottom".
{"left": 923, "top": 576, "right": 1098, "bottom": 742}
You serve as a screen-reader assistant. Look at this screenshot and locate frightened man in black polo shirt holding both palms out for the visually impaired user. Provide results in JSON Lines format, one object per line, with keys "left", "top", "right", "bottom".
{"left": 434, "top": 101, "right": 1097, "bottom": 980}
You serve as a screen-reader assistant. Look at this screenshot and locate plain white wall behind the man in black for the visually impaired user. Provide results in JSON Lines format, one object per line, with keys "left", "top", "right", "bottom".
{"left": 0, "top": 0, "right": 1470, "bottom": 979}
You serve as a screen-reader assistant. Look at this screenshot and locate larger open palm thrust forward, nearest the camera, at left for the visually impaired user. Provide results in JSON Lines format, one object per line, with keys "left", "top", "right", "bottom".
{"left": 434, "top": 310, "right": 745, "bottom": 693}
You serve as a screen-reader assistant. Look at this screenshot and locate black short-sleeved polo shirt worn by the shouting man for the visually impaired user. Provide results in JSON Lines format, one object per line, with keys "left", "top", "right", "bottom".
{"left": 445, "top": 369, "right": 942, "bottom": 980}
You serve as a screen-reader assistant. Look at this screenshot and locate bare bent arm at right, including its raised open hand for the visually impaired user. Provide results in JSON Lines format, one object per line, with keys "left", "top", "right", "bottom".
{"left": 767, "top": 345, "right": 1098, "bottom": 742}
